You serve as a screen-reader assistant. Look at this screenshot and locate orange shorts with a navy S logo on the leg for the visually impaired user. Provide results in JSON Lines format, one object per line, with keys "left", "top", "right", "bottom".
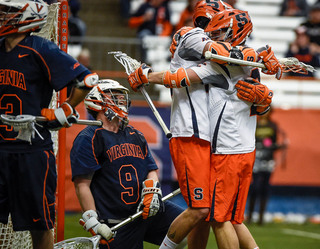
{"left": 169, "top": 137, "right": 211, "bottom": 208}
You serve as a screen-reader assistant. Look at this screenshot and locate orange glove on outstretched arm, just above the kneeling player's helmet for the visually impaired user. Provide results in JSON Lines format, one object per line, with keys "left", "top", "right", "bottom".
{"left": 128, "top": 63, "right": 152, "bottom": 92}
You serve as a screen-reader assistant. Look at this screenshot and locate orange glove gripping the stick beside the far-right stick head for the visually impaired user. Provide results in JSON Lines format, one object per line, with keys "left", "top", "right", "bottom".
{"left": 257, "top": 45, "right": 282, "bottom": 80}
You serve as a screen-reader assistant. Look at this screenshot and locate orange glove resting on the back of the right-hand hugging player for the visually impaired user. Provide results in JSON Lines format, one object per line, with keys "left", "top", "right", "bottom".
{"left": 235, "top": 78, "right": 273, "bottom": 105}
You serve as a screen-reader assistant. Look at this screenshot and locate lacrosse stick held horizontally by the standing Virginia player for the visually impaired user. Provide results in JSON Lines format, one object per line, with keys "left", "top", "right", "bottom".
{"left": 0, "top": 114, "right": 102, "bottom": 144}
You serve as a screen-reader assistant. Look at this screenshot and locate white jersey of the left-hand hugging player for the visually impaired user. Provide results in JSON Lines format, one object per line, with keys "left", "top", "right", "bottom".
{"left": 170, "top": 28, "right": 210, "bottom": 141}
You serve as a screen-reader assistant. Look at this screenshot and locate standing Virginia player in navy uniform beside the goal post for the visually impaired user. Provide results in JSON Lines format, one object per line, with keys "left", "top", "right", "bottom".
{"left": 0, "top": 0, "right": 98, "bottom": 249}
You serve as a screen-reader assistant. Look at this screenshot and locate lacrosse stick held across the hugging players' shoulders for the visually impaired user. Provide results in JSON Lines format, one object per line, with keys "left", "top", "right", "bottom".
{"left": 205, "top": 51, "right": 316, "bottom": 74}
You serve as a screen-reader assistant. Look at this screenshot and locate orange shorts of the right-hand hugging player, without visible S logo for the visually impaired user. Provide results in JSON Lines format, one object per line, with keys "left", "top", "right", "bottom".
{"left": 207, "top": 151, "right": 255, "bottom": 224}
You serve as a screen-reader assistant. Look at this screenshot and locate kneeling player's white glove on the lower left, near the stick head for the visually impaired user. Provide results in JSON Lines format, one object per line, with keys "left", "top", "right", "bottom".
{"left": 79, "top": 210, "right": 114, "bottom": 240}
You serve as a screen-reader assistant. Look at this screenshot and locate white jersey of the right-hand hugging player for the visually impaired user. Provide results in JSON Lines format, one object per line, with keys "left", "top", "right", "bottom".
{"left": 192, "top": 62, "right": 256, "bottom": 154}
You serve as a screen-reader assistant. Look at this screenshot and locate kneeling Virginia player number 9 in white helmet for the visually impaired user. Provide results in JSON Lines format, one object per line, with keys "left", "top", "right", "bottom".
{"left": 70, "top": 79, "right": 186, "bottom": 249}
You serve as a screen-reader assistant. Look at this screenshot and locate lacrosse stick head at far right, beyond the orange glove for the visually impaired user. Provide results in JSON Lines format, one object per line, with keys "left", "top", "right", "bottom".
{"left": 279, "top": 57, "right": 316, "bottom": 74}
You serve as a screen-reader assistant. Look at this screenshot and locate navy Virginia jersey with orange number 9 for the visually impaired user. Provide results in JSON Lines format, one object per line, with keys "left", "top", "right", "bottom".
{"left": 70, "top": 126, "right": 158, "bottom": 220}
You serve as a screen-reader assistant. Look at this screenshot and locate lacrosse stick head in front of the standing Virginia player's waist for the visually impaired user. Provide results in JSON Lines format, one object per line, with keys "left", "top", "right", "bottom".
{"left": 1, "top": 114, "right": 36, "bottom": 143}
